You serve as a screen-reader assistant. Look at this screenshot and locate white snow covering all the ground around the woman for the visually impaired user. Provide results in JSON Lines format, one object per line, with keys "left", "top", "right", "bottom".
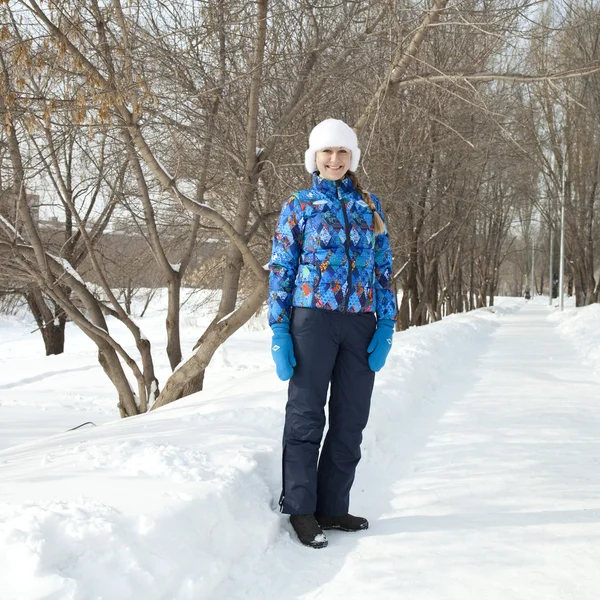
{"left": 0, "top": 297, "right": 600, "bottom": 600}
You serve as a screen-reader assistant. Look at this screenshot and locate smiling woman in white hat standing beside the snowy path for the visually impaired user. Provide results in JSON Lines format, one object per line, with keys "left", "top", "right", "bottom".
{"left": 269, "top": 119, "right": 396, "bottom": 548}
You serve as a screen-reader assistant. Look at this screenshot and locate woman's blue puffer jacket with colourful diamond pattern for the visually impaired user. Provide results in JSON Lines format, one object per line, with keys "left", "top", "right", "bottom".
{"left": 269, "top": 174, "right": 396, "bottom": 325}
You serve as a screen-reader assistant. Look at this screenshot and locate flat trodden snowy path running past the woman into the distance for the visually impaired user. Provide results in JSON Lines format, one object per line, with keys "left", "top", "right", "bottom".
{"left": 224, "top": 303, "right": 600, "bottom": 600}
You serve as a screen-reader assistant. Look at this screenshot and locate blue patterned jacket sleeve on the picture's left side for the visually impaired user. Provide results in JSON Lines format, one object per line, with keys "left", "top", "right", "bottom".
{"left": 269, "top": 194, "right": 304, "bottom": 325}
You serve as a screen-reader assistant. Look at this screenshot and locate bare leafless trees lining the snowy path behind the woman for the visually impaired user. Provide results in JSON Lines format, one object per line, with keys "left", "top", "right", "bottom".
{"left": 0, "top": 0, "right": 600, "bottom": 416}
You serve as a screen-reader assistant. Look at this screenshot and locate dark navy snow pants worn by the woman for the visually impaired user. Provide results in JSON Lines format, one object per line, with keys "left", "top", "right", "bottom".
{"left": 281, "top": 308, "right": 376, "bottom": 516}
